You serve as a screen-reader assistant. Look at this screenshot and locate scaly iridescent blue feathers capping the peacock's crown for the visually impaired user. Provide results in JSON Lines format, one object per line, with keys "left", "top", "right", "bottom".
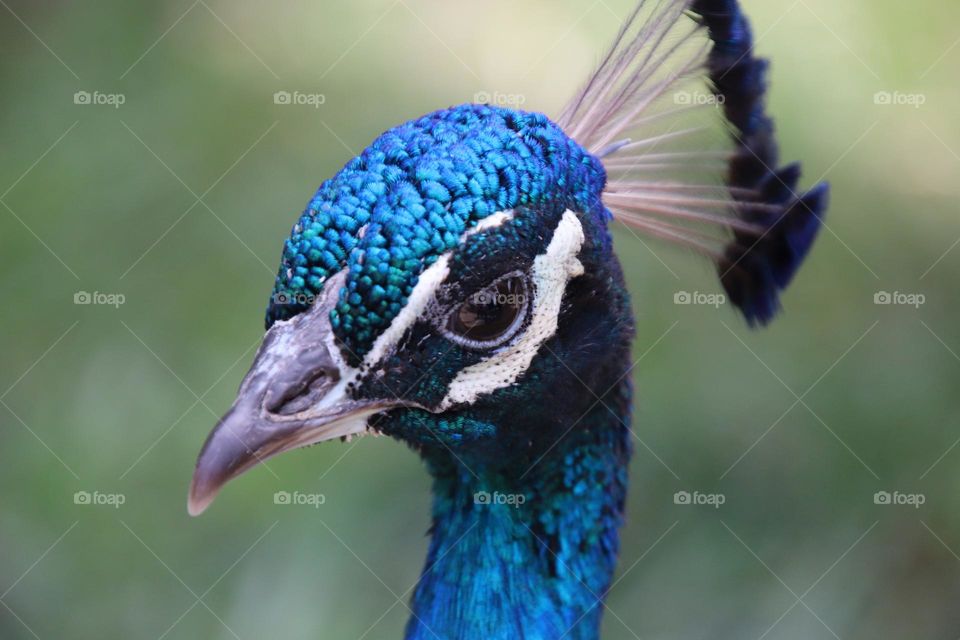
{"left": 267, "top": 104, "right": 609, "bottom": 362}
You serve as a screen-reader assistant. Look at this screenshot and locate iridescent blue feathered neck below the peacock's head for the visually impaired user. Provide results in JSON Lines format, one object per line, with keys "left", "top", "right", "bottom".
{"left": 406, "top": 382, "right": 630, "bottom": 640}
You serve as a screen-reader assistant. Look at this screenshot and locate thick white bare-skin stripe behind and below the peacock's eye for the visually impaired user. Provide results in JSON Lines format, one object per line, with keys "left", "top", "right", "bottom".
{"left": 439, "top": 210, "right": 584, "bottom": 411}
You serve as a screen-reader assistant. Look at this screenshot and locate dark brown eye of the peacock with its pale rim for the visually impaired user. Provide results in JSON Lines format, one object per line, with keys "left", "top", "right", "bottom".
{"left": 445, "top": 274, "right": 529, "bottom": 349}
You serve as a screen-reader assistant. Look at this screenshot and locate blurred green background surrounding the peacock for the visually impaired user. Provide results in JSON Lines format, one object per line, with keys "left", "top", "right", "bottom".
{"left": 0, "top": 0, "right": 960, "bottom": 640}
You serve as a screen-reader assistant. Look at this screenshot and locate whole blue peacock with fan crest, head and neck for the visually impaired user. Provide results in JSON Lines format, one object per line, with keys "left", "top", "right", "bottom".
{"left": 188, "top": 0, "right": 828, "bottom": 640}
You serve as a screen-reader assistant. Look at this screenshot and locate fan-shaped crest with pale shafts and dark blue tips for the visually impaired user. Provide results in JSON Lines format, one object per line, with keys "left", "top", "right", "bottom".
{"left": 557, "top": 0, "right": 828, "bottom": 325}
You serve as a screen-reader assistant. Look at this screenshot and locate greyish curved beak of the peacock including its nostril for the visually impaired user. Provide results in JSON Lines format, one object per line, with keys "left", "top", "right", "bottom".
{"left": 187, "top": 277, "right": 396, "bottom": 515}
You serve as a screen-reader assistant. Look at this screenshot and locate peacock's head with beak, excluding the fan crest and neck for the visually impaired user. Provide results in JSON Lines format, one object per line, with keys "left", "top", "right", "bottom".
{"left": 190, "top": 105, "right": 633, "bottom": 512}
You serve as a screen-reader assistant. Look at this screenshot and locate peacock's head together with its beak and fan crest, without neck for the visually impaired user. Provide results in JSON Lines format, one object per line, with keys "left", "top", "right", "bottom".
{"left": 189, "top": 0, "right": 828, "bottom": 513}
